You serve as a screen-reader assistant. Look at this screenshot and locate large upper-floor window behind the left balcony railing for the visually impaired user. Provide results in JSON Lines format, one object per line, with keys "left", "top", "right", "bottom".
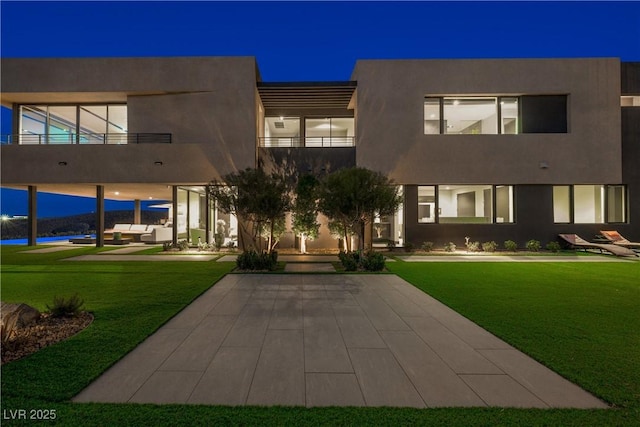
{"left": 19, "top": 105, "right": 127, "bottom": 144}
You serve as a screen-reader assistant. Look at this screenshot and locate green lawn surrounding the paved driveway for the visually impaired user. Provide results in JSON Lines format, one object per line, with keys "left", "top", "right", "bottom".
{"left": 2, "top": 246, "right": 640, "bottom": 426}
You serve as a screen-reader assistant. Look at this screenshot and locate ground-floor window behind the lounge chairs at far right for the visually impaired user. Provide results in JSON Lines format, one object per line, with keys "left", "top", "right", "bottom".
{"left": 553, "top": 185, "right": 627, "bottom": 224}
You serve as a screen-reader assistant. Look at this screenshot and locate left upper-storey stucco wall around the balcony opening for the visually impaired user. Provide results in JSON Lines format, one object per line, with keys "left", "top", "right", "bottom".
{"left": 2, "top": 57, "right": 258, "bottom": 184}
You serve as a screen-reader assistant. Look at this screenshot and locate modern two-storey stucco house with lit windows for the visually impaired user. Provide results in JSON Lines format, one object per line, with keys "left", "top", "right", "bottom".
{"left": 0, "top": 57, "right": 640, "bottom": 251}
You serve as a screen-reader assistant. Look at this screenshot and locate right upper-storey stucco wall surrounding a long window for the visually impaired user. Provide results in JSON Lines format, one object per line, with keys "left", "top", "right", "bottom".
{"left": 352, "top": 59, "right": 622, "bottom": 184}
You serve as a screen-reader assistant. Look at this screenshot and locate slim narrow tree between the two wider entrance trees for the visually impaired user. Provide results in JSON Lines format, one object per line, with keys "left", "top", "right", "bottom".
{"left": 291, "top": 174, "right": 320, "bottom": 253}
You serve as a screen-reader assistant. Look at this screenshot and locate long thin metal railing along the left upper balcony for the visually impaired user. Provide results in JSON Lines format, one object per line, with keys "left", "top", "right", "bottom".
{"left": 0, "top": 133, "right": 171, "bottom": 145}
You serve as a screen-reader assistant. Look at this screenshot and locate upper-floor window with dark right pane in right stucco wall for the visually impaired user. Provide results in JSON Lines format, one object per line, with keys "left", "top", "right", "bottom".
{"left": 424, "top": 95, "right": 567, "bottom": 135}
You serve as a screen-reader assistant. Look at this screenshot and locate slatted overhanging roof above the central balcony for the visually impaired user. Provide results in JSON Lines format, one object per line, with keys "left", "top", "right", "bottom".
{"left": 258, "top": 81, "right": 357, "bottom": 110}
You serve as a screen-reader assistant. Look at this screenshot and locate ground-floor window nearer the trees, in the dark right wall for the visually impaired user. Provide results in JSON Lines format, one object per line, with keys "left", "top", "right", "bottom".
{"left": 418, "top": 185, "right": 515, "bottom": 224}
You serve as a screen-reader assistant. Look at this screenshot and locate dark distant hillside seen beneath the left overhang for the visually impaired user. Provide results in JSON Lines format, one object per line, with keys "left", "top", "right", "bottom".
{"left": 0, "top": 210, "right": 167, "bottom": 240}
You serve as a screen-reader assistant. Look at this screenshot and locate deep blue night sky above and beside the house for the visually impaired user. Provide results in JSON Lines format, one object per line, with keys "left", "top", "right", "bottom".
{"left": 0, "top": 1, "right": 640, "bottom": 217}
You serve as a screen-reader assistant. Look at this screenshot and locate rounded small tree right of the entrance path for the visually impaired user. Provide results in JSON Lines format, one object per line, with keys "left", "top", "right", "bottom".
{"left": 318, "top": 167, "right": 402, "bottom": 251}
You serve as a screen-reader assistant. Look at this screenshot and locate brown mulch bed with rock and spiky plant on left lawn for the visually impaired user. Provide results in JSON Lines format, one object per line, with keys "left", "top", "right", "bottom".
{"left": 2, "top": 312, "right": 93, "bottom": 365}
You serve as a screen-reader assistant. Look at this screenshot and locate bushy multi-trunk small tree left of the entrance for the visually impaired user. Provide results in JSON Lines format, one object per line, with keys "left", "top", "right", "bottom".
{"left": 207, "top": 168, "right": 291, "bottom": 252}
